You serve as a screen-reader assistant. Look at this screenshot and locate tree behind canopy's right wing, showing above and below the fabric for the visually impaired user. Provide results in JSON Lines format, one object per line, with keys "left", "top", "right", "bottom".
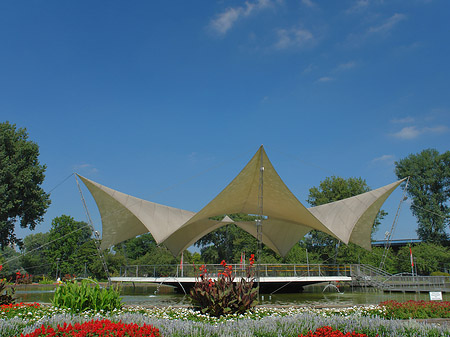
{"left": 306, "top": 176, "right": 387, "bottom": 262}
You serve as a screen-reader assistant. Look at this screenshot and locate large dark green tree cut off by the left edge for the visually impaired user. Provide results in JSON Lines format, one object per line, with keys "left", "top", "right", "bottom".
{"left": 0, "top": 122, "right": 50, "bottom": 248}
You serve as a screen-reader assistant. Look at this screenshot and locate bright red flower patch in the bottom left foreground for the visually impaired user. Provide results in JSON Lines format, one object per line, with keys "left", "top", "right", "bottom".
{"left": 20, "top": 319, "right": 160, "bottom": 337}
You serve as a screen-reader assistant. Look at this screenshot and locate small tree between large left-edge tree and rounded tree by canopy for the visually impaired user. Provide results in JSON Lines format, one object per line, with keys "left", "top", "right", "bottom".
{"left": 21, "top": 233, "right": 50, "bottom": 275}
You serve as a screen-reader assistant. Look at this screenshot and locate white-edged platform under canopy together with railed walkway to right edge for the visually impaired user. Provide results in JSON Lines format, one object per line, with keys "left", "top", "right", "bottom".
{"left": 111, "top": 264, "right": 450, "bottom": 293}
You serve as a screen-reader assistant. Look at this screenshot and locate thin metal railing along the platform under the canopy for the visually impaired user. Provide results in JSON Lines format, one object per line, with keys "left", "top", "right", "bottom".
{"left": 120, "top": 264, "right": 352, "bottom": 278}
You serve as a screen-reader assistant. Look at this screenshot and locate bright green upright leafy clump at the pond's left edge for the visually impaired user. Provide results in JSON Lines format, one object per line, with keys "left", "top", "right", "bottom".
{"left": 52, "top": 280, "right": 122, "bottom": 313}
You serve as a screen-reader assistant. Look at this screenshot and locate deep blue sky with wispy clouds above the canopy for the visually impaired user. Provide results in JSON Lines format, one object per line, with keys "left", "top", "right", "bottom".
{"left": 0, "top": 0, "right": 450, "bottom": 247}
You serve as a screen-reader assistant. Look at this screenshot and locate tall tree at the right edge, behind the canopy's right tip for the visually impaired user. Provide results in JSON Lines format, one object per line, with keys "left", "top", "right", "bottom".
{"left": 395, "top": 149, "right": 450, "bottom": 243}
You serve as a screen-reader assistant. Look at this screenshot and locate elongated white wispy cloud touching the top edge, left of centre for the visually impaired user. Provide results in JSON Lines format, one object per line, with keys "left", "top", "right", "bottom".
{"left": 209, "top": 0, "right": 272, "bottom": 35}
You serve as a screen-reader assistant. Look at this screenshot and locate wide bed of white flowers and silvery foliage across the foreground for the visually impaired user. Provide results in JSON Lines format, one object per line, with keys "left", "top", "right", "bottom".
{"left": 0, "top": 305, "right": 450, "bottom": 337}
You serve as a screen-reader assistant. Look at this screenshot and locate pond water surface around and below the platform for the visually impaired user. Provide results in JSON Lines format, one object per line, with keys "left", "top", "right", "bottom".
{"left": 11, "top": 285, "right": 450, "bottom": 306}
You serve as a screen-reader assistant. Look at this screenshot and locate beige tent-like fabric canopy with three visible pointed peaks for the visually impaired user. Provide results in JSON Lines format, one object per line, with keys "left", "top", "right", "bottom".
{"left": 79, "top": 146, "right": 402, "bottom": 256}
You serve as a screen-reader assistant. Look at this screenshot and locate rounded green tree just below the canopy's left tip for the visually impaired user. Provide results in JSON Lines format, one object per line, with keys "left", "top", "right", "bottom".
{"left": 48, "top": 215, "right": 95, "bottom": 276}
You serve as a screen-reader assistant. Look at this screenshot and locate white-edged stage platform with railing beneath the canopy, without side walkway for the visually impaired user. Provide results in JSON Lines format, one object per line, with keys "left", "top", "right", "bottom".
{"left": 111, "top": 264, "right": 352, "bottom": 293}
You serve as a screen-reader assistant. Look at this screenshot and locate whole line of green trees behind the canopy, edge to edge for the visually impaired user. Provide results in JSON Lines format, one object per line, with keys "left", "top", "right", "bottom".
{"left": 0, "top": 122, "right": 450, "bottom": 279}
